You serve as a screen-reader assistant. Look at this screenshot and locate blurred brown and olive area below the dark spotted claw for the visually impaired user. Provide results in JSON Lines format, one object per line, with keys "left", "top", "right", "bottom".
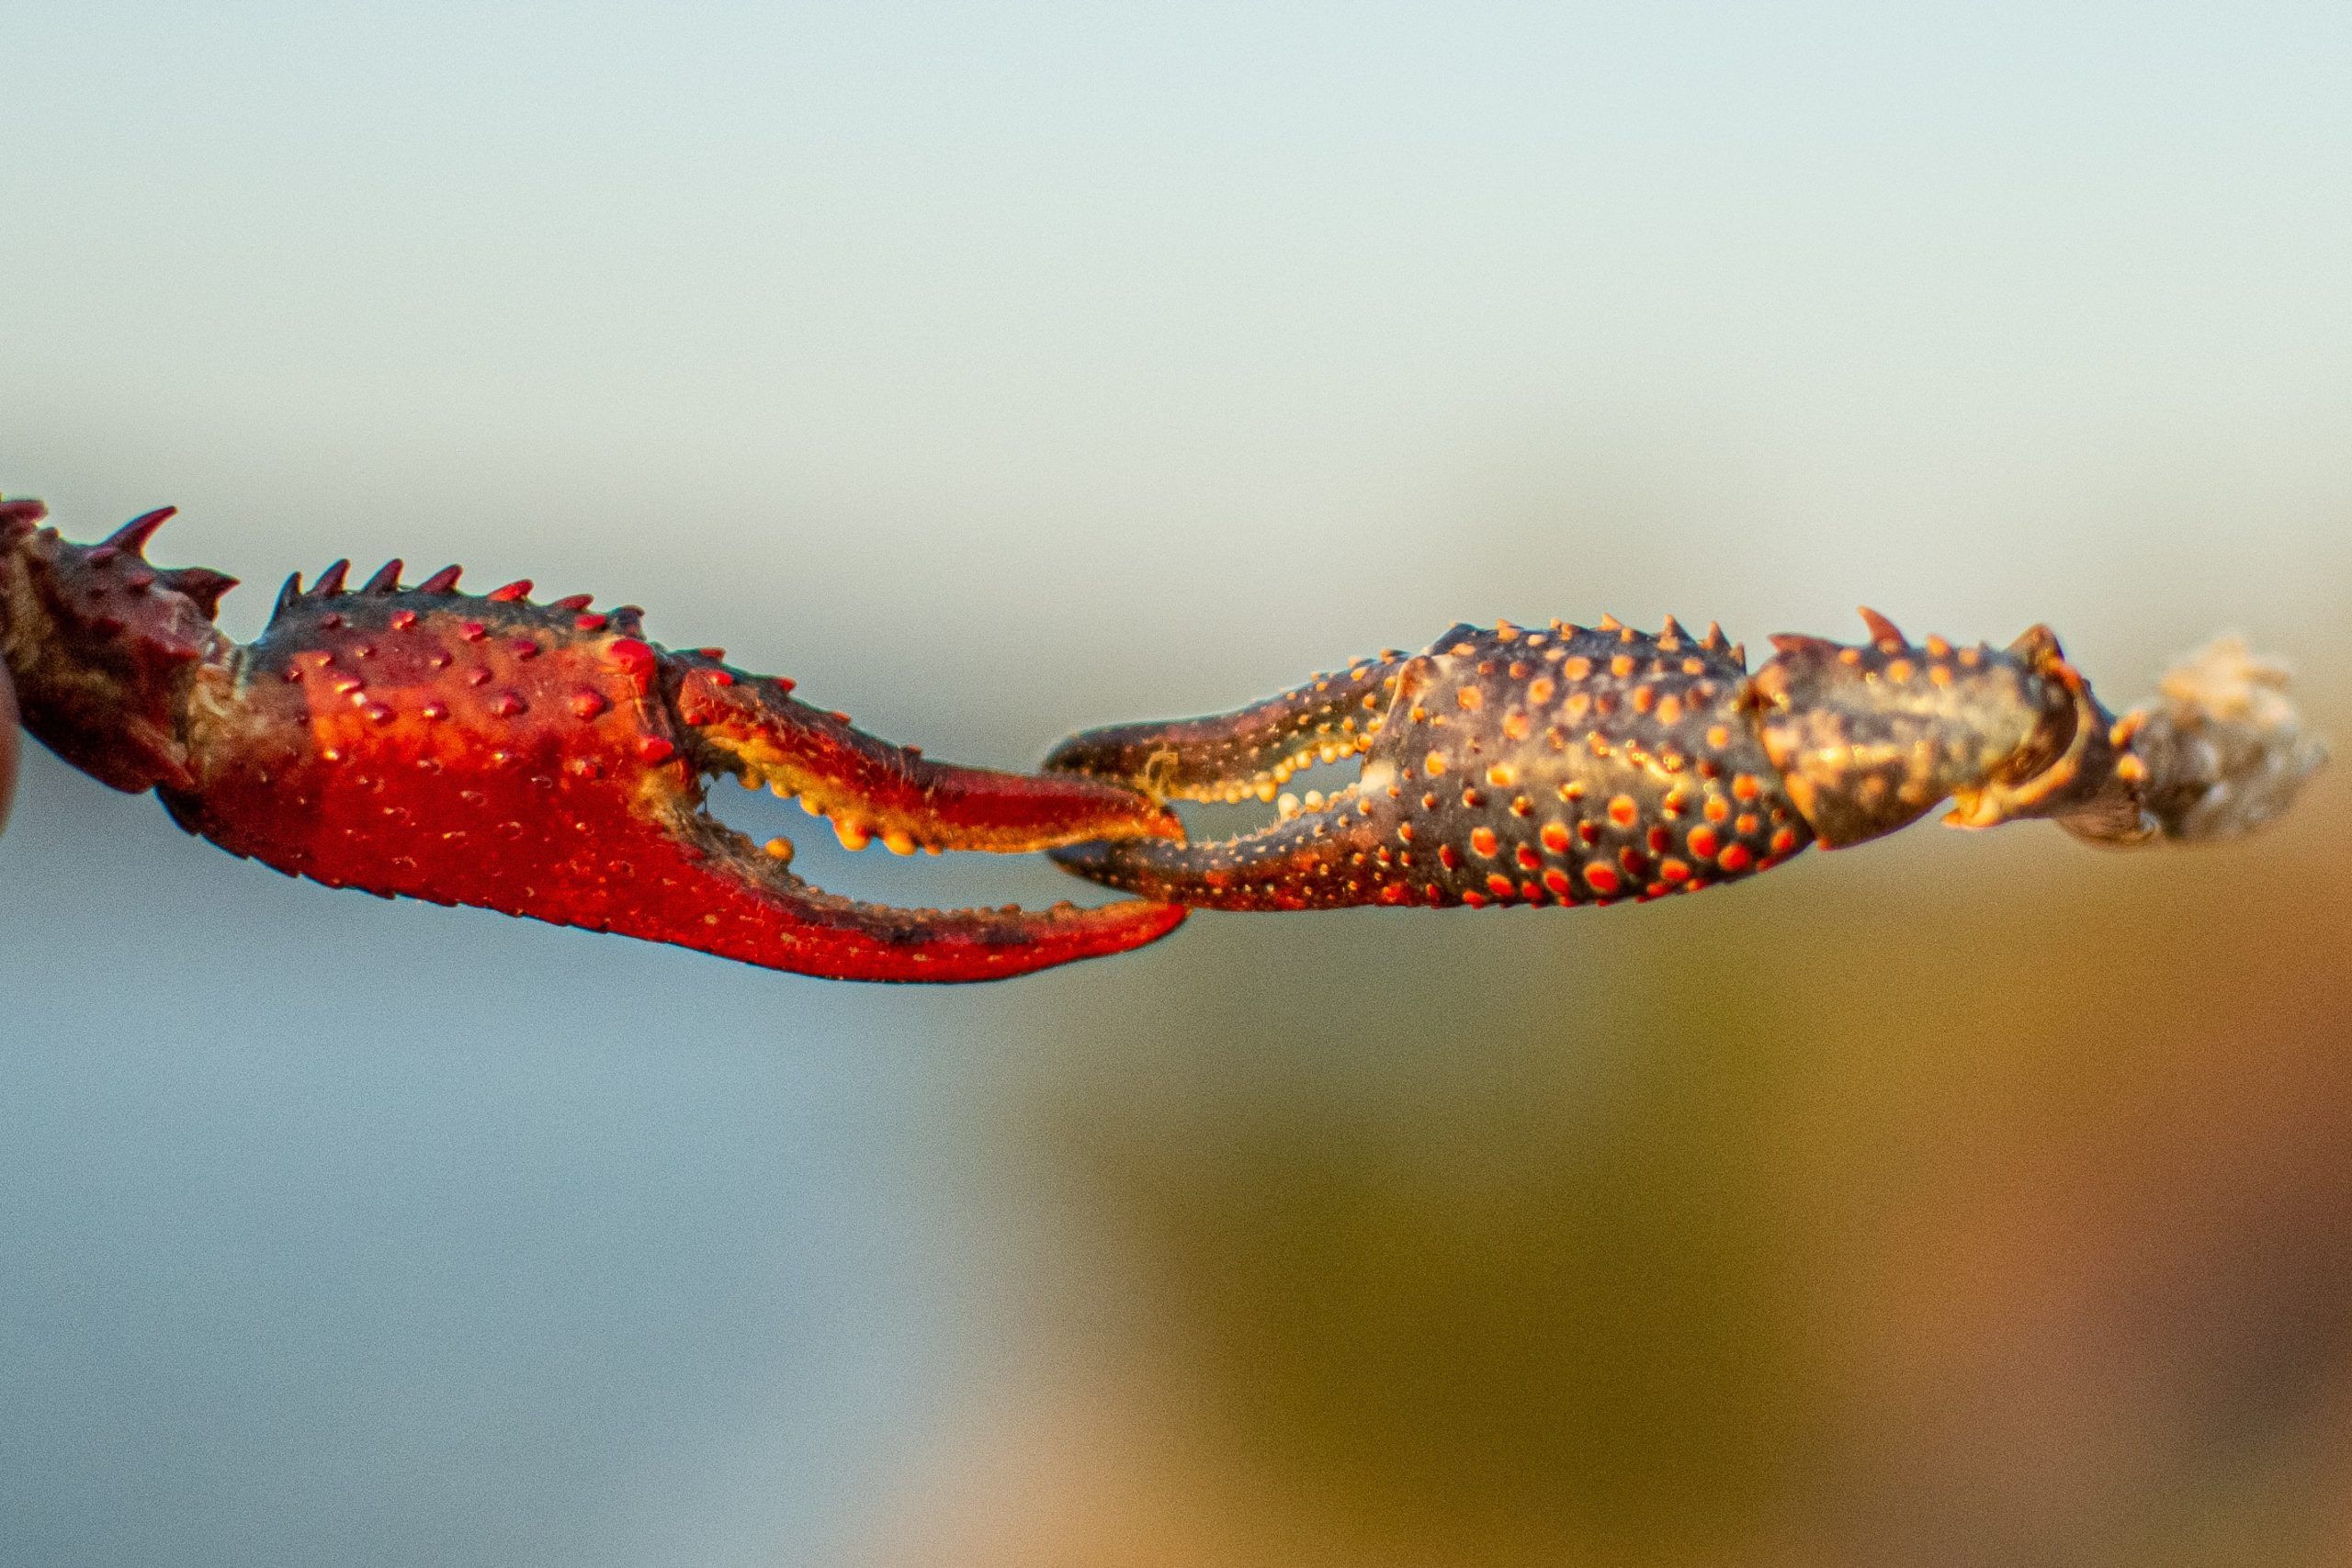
{"left": 877, "top": 689, "right": 2352, "bottom": 1568}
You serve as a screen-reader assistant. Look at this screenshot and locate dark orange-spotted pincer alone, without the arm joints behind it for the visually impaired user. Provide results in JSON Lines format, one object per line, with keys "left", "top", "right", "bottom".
{"left": 1045, "top": 621, "right": 1811, "bottom": 909}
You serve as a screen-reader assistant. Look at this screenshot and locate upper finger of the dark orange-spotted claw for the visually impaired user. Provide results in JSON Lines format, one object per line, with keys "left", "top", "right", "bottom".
{"left": 1045, "top": 653, "right": 1408, "bottom": 804}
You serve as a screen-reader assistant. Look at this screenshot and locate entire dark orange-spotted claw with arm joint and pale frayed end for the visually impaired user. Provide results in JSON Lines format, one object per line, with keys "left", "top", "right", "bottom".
{"left": 1046, "top": 611, "right": 2324, "bottom": 909}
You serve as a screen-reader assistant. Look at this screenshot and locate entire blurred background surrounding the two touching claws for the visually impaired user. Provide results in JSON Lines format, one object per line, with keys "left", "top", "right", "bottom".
{"left": 0, "top": 0, "right": 2352, "bottom": 1568}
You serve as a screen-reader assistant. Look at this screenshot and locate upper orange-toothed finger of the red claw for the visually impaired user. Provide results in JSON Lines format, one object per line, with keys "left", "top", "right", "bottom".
{"left": 668, "top": 656, "right": 1183, "bottom": 853}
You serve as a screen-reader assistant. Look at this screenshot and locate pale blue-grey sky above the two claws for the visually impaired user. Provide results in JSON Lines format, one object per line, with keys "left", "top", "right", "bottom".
{"left": 0, "top": 5, "right": 2352, "bottom": 707}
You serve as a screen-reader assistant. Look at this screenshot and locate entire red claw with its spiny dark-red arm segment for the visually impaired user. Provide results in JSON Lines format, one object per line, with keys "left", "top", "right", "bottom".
{"left": 0, "top": 503, "right": 1183, "bottom": 980}
